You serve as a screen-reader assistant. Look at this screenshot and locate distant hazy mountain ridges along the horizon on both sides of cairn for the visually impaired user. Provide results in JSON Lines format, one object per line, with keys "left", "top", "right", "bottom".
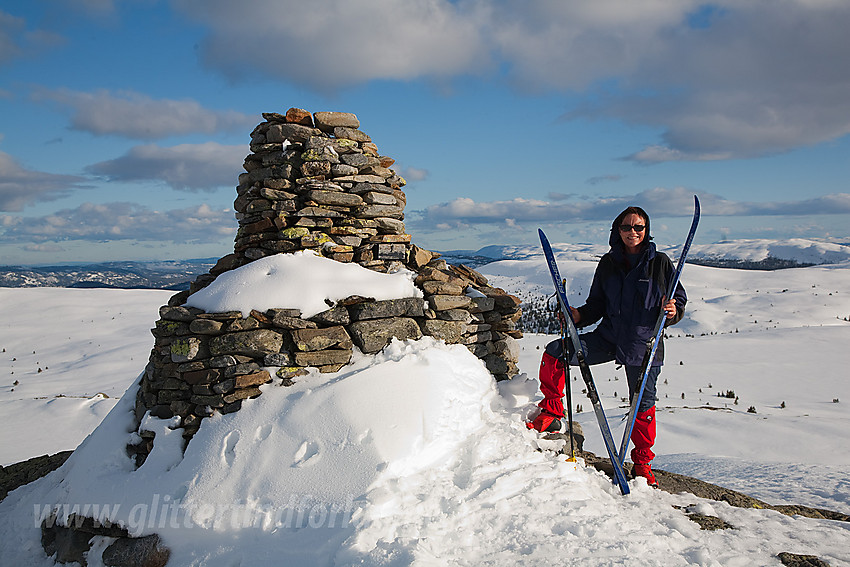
{"left": 0, "top": 238, "right": 850, "bottom": 291}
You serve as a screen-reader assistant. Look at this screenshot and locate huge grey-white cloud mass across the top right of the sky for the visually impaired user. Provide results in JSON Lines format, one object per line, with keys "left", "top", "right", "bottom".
{"left": 173, "top": 0, "right": 850, "bottom": 163}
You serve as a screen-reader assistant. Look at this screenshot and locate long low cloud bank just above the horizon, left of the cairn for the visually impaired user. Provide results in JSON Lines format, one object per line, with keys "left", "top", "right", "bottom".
{"left": 0, "top": 203, "right": 236, "bottom": 245}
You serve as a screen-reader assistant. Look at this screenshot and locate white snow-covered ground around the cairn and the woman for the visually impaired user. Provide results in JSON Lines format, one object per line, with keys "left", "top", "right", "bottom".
{"left": 0, "top": 247, "right": 850, "bottom": 567}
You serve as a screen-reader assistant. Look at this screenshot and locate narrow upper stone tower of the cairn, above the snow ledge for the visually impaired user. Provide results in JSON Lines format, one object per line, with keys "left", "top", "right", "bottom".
{"left": 187, "top": 108, "right": 410, "bottom": 285}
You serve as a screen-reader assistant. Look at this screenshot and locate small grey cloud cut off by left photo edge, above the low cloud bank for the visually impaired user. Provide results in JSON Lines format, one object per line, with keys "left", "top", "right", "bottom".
{"left": 0, "top": 152, "right": 85, "bottom": 211}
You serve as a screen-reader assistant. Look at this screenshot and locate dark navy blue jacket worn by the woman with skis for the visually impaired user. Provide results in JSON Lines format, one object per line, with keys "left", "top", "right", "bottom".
{"left": 578, "top": 238, "right": 688, "bottom": 366}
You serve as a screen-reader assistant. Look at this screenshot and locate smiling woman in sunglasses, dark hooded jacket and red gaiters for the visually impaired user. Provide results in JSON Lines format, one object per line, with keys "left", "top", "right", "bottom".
{"left": 527, "top": 207, "right": 687, "bottom": 486}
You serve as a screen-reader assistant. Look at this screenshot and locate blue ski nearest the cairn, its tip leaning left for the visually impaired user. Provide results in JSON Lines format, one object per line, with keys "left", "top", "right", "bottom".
{"left": 537, "top": 229, "right": 629, "bottom": 495}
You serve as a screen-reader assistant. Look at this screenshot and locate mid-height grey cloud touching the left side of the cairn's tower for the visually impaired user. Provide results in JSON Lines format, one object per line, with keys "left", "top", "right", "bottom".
{"left": 86, "top": 142, "right": 245, "bottom": 191}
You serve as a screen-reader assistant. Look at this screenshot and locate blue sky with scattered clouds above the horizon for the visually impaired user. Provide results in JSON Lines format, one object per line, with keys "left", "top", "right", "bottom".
{"left": 0, "top": 0, "right": 850, "bottom": 264}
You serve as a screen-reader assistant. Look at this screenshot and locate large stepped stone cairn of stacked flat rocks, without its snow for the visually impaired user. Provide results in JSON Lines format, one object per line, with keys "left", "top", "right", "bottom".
{"left": 128, "top": 108, "right": 522, "bottom": 466}
